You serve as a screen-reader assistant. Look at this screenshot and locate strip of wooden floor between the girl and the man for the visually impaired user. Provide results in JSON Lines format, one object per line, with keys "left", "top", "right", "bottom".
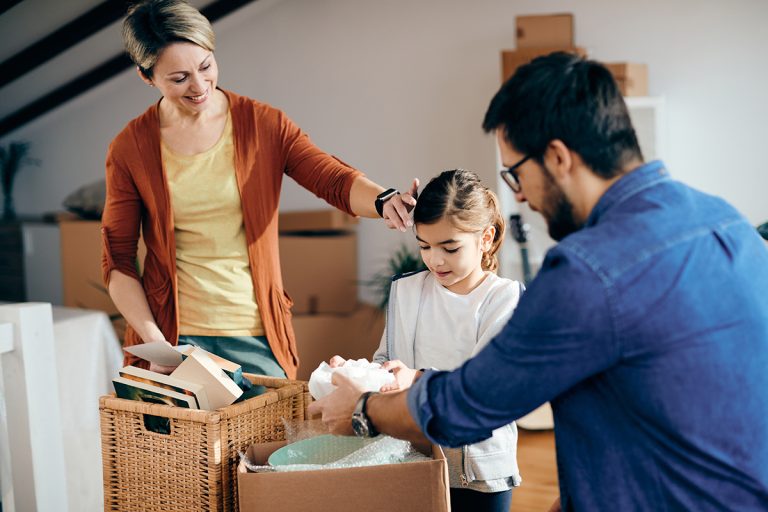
{"left": 510, "top": 428, "right": 559, "bottom": 512}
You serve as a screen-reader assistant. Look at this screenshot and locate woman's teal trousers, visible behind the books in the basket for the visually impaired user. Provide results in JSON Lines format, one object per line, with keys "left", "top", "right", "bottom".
{"left": 179, "top": 335, "right": 287, "bottom": 401}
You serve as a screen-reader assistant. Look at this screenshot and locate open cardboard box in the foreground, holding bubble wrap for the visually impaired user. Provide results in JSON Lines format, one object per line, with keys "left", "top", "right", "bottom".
{"left": 237, "top": 442, "right": 450, "bottom": 512}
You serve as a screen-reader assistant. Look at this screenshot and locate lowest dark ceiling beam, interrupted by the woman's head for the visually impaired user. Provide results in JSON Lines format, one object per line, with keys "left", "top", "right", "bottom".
{"left": 0, "top": 0, "right": 255, "bottom": 137}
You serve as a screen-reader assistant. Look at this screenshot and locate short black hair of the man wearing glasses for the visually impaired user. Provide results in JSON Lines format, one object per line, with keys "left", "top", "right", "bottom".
{"left": 483, "top": 52, "right": 643, "bottom": 178}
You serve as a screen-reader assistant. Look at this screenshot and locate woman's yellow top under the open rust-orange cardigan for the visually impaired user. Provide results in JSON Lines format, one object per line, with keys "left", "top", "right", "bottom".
{"left": 162, "top": 113, "right": 264, "bottom": 336}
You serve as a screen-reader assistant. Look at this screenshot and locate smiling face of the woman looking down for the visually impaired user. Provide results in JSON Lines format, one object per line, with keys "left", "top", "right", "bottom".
{"left": 142, "top": 43, "right": 219, "bottom": 115}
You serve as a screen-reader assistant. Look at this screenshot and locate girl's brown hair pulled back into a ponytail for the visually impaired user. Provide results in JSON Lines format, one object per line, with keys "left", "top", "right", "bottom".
{"left": 413, "top": 169, "right": 505, "bottom": 272}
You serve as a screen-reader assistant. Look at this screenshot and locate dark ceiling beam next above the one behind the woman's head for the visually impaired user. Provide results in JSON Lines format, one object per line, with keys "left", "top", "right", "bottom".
{"left": 0, "top": 0, "right": 128, "bottom": 87}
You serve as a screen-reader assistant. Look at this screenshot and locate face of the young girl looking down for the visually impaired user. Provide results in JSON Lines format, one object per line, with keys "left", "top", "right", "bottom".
{"left": 416, "top": 218, "right": 496, "bottom": 295}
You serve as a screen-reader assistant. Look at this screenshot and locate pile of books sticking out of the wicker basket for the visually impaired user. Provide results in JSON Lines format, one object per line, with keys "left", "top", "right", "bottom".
{"left": 112, "top": 342, "right": 247, "bottom": 411}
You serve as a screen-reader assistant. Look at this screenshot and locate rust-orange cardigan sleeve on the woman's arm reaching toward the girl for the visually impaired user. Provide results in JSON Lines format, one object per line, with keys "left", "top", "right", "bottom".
{"left": 278, "top": 108, "right": 364, "bottom": 215}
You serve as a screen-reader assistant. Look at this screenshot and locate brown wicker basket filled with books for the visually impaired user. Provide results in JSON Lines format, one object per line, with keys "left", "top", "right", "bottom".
{"left": 99, "top": 375, "right": 309, "bottom": 512}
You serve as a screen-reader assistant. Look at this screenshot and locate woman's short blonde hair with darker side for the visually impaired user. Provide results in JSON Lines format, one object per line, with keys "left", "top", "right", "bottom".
{"left": 123, "top": 0, "right": 216, "bottom": 78}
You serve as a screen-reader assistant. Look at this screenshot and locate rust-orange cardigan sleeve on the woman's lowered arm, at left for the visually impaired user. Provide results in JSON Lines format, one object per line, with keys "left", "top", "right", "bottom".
{"left": 101, "top": 138, "right": 141, "bottom": 286}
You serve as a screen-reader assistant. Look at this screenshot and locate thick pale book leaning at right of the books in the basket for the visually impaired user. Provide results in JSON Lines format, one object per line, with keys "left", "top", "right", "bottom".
{"left": 171, "top": 348, "right": 243, "bottom": 410}
